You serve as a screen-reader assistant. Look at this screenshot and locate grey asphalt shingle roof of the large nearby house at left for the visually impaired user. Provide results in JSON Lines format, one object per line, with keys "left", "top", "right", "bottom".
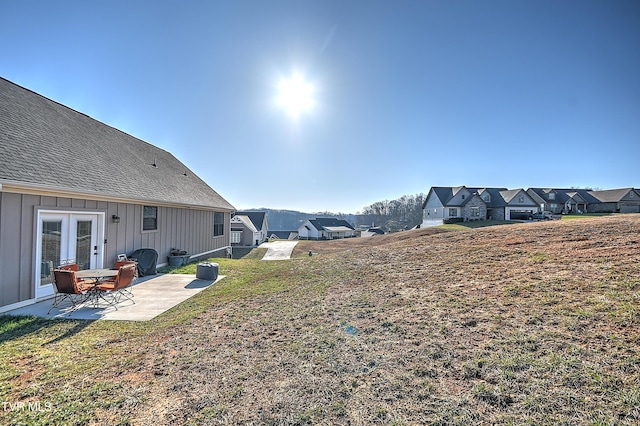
{"left": 0, "top": 77, "right": 234, "bottom": 210}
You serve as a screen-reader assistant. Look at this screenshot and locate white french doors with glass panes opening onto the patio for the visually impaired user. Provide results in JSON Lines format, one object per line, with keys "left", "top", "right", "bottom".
{"left": 35, "top": 211, "right": 104, "bottom": 298}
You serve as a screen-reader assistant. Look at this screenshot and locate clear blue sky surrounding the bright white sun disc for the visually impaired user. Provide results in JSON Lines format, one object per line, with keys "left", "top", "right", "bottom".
{"left": 0, "top": 0, "right": 640, "bottom": 213}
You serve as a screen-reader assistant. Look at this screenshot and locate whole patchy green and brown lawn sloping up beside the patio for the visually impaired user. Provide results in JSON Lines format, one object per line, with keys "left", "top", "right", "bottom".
{"left": 0, "top": 215, "right": 640, "bottom": 425}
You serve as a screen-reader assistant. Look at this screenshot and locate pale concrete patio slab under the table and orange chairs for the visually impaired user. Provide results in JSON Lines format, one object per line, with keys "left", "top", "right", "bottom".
{"left": 3, "top": 274, "right": 224, "bottom": 321}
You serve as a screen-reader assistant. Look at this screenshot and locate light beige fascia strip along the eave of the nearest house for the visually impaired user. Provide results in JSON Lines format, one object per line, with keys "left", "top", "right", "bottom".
{"left": 0, "top": 179, "right": 235, "bottom": 213}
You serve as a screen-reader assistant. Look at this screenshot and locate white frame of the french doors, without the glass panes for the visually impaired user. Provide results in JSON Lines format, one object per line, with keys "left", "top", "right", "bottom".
{"left": 34, "top": 209, "right": 106, "bottom": 299}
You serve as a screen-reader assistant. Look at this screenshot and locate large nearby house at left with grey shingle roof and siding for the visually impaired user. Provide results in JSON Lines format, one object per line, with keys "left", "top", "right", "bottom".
{"left": 0, "top": 78, "right": 234, "bottom": 311}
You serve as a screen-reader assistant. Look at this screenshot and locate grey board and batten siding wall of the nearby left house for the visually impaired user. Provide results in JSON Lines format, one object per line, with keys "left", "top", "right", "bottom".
{"left": 0, "top": 191, "right": 231, "bottom": 309}
